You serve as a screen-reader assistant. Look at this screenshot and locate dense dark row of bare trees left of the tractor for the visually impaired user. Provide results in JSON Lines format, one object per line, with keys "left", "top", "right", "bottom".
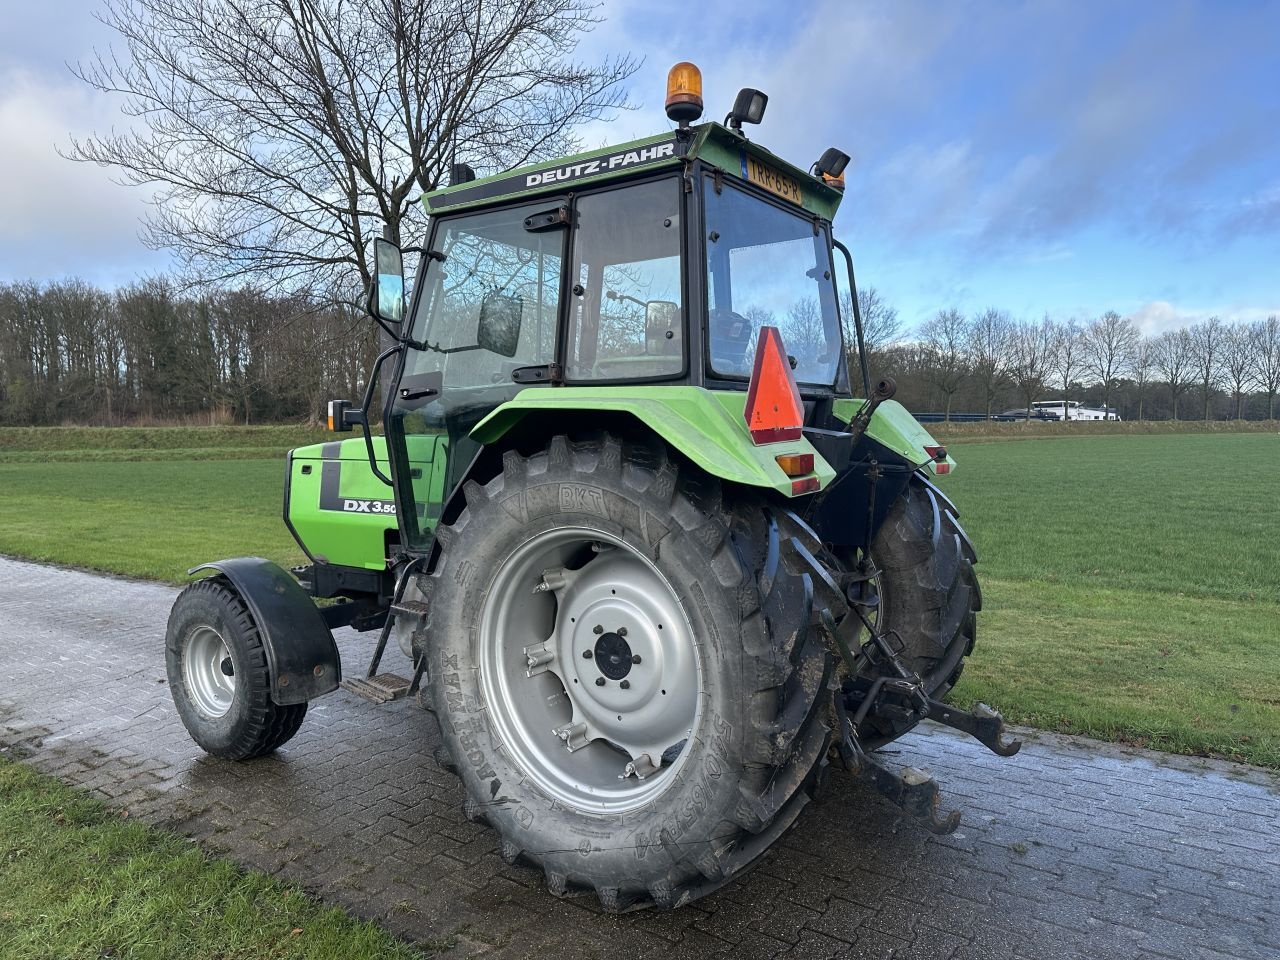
{"left": 0, "top": 278, "right": 378, "bottom": 425}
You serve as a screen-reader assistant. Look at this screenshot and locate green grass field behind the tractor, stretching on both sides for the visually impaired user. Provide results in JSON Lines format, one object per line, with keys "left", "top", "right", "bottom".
{"left": 0, "top": 424, "right": 1280, "bottom": 768}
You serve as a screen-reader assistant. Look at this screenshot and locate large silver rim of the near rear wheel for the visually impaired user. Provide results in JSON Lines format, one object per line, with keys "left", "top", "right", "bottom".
{"left": 479, "top": 527, "right": 701, "bottom": 814}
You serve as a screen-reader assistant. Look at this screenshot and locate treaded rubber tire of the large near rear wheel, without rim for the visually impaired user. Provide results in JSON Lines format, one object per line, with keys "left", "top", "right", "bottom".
{"left": 422, "top": 436, "right": 832, "bottom": 911}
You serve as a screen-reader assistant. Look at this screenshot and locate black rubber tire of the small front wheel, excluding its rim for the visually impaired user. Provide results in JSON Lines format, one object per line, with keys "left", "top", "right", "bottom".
{"left": 165, "top": 577, "right": 307, "bottom": 760}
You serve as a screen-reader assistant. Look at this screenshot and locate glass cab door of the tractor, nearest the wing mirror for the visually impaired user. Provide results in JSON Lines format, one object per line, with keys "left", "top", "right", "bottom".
{"left": 385, "top": 198, "right": 568, "bottom": 552}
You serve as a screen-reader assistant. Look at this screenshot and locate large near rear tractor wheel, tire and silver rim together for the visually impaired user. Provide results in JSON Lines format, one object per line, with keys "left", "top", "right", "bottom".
{"left": 422, "top": 436, "right": 832, "bottom": 910}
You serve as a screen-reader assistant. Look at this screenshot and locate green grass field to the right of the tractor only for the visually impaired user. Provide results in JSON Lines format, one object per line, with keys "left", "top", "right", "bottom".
{"left": 946, "top": 434, "right": 1280, "bottom": 767}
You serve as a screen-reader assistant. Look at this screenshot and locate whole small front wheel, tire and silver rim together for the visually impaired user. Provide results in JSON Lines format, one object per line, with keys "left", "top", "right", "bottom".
{"left": 165, "top": 577, "right": 307, "bottom": 760}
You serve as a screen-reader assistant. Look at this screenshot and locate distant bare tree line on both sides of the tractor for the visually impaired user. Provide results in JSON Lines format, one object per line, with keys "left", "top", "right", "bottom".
{"left": 0, "top": 278, "right": 1280, "bottom": 425}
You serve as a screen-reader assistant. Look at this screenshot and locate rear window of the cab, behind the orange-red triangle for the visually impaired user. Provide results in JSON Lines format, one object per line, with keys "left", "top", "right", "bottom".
{"left": 707, "top": 182, "right": 842, "bottom": 385}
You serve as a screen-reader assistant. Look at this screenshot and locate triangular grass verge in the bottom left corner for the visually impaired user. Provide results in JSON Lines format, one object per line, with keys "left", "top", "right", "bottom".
{"left": 0, "top": 759, "right": 424, "bottom": 960}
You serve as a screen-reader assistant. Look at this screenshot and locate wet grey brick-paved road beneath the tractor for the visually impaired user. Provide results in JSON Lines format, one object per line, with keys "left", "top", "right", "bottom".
{"left": 0, "top": 558, "right": 1280, "bottom": 960}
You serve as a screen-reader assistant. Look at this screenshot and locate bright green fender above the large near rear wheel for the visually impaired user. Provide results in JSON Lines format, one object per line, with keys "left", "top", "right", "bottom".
{"left": 471, "top": 387, "right": 836, "bottom": 497}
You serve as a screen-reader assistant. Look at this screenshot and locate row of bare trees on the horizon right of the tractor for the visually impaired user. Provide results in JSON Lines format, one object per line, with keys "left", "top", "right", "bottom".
{"left": 880, "top": 308, "right": 1280, "bottom": 420}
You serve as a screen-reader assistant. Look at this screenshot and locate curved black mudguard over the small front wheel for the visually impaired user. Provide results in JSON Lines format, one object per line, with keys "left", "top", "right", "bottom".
{"left": 187, "top": 557, "right": 342, "bottom": 705}
